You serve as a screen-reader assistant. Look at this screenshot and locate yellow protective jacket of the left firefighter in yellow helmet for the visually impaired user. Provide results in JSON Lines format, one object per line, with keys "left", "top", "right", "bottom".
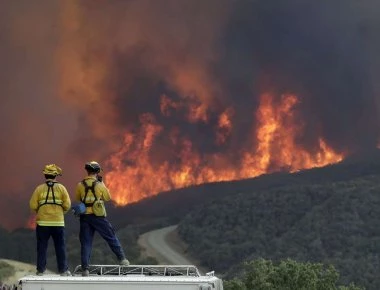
{"left": 29, "top": 179, "right": 71, "bottom": 227}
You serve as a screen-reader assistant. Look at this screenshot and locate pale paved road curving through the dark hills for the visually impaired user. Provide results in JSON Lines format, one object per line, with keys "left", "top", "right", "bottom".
{"left": 139, "top": 225, "right": 193, "bottom": 265}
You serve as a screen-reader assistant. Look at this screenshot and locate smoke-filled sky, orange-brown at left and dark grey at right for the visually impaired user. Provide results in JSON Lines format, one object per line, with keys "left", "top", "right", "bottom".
{"left": 0, "top": 0, "right": 380, "bottom": 228}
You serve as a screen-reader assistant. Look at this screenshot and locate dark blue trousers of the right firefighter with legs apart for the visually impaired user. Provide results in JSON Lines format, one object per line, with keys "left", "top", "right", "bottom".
{"left": 79, "top": 214, "right": 125, "bottom": 269}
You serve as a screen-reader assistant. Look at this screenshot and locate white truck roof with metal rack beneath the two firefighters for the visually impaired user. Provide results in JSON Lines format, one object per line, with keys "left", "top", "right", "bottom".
{"left": 17, "top": 265, "right": 223, "bottom": 290}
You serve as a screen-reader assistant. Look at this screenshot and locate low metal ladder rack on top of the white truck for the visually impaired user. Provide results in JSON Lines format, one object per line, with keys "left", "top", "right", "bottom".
{"left": 73, "top": 265, "right": 201, "bottom": 277}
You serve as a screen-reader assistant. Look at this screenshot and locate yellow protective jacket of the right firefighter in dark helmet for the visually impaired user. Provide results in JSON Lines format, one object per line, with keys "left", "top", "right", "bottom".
{"left": 75, "top": 176, "right": 111, "bottom": 214}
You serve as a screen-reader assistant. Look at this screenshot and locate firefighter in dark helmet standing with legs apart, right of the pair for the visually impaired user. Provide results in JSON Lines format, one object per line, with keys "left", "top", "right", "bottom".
{"left": 75, "top": 161, "right": 129, "bottom": 276}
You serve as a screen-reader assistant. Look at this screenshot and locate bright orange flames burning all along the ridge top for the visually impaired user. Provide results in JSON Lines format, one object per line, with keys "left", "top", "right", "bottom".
{"left": 106, "top": 94, "right": 344, "bottom": 205}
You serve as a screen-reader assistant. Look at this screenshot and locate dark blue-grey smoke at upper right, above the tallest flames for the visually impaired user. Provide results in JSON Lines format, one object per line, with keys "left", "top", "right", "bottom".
{"left": 225, "top": 1, "right": 379, "bottom": 152}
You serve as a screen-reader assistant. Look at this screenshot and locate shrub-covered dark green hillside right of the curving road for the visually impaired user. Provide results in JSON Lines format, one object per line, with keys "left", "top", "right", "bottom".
{"left": 179, "top": 174, "right": 380, "bottom": 289}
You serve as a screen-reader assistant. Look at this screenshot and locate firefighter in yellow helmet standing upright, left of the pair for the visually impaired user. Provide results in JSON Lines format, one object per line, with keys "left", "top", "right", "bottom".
{"left": 29, "top": 164, "right": 71, "bottom": 276}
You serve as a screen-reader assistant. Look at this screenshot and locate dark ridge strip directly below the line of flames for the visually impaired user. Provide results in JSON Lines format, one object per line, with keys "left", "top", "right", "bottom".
{"left": 109, "top": 150, "right": 380, "bottom": 228}
